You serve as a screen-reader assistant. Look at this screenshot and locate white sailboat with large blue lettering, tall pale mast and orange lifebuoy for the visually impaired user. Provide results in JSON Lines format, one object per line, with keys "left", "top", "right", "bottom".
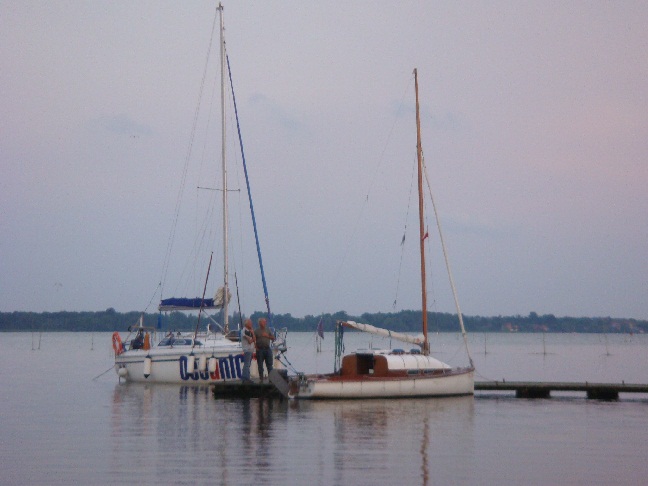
{"left": 112, "top": 4, "right": 287, "bottom": 385}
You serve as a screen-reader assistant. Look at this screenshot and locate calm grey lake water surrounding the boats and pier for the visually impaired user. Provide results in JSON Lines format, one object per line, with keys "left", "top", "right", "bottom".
{"left": 0, "top": 333, "right": 648, "bottom": 485}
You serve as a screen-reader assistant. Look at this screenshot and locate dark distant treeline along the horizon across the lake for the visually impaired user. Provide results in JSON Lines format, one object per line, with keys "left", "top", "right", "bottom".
{"left": 0, "top": 308, "right": 648, "bottom": 333}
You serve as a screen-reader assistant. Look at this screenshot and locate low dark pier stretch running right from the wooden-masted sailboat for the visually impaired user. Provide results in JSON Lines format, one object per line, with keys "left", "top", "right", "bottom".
{"left": 475, "top": 381, "right": 648, "bottom": 400}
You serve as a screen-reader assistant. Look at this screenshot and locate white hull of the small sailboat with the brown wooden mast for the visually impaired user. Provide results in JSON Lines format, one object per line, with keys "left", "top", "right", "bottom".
{"left": 289, "top": 369, "right": 475, "bottom": 399}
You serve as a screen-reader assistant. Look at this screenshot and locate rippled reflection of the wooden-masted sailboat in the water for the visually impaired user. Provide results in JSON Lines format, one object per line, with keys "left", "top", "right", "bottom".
{"left": 291, "top": 397, "right": 474, "bottom": 485}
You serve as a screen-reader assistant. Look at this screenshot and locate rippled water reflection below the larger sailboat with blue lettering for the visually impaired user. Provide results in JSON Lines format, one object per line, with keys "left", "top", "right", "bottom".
{"left": 111, "top": 384, "right": 287, "bottom": 484}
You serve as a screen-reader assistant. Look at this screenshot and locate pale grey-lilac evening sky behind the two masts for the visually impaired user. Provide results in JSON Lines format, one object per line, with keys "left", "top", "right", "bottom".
{"left": 0, "top": 0, "right": 648, "bottom": 319}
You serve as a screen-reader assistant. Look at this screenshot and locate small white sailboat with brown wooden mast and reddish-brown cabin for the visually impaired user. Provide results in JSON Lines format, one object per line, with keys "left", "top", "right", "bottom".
{"left": 286, "top": 69, "right": 475, "bottom": 399}
